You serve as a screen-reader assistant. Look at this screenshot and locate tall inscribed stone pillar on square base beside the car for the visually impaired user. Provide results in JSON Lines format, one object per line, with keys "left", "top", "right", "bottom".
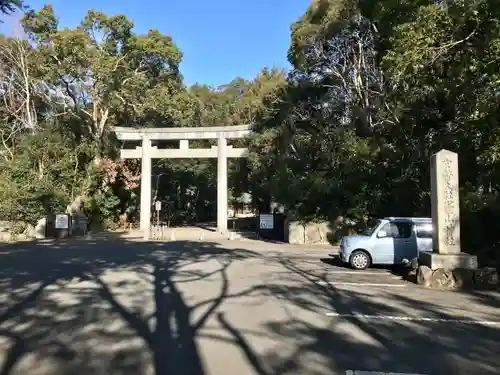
{"left": 419, "top": 150, "right": 477, "bottom": 269}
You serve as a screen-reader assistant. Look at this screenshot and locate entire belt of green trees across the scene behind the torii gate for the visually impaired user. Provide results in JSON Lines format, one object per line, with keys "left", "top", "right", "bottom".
{"left": 0, "top": 0, "right": 500, "bottom": 256}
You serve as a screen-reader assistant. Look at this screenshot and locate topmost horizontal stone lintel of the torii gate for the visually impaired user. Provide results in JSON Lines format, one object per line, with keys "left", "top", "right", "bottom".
{"left": 113, "top": 125, "right": 252, "bottom": 141}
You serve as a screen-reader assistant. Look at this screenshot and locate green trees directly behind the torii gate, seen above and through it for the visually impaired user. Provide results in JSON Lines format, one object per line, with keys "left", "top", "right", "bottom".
{"left": 148, "top": 69, "right": 285, "bottom": 224}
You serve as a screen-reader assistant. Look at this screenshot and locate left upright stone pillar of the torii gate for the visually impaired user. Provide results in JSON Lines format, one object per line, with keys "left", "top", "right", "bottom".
{"left": 141, "top": 137, "right": 151, "bottom": 239}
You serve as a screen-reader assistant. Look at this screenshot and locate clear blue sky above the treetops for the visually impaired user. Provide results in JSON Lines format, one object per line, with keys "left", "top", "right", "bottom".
{"left": 2, "top": 0, "right": 311, "bottom": 85}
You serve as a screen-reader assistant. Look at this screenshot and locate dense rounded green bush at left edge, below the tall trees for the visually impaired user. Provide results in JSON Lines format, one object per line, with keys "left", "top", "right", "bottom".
{"left": 0, "top": 129, "right": 86, "bottom": 224}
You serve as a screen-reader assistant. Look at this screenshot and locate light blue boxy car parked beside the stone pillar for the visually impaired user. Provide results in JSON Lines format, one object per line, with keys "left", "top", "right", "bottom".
{"left": 340, "top": 217, "right": 433, "bottom": 270}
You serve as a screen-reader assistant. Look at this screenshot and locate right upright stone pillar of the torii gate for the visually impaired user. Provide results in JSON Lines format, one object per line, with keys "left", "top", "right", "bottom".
{"left": 217, "top": 135, "right": 227, "bottom": 235}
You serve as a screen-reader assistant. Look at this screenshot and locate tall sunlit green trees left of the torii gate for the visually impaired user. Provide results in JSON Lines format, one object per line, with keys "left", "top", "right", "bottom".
{"left": 0, "top": 5, "right": 190, "bottom": 229}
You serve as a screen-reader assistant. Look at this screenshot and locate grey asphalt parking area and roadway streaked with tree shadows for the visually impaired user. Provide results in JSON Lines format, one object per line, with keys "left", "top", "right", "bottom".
{"left": 0, "top": 237, "right": 500, "bottom": 375}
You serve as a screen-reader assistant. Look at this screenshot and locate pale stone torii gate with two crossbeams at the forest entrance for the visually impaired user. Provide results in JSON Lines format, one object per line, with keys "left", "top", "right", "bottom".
{"left": 113, "top": 125, "right": 251, "bottom": 238}
